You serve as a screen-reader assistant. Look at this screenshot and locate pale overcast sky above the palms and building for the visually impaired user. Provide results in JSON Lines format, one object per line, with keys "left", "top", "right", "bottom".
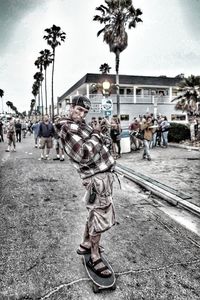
{"left": 0, "top": 0, "right": 200, "bottom": 112}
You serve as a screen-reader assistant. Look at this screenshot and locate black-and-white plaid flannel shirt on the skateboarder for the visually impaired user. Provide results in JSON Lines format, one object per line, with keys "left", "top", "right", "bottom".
{"left": 60, "top": 119, "right": 115, "bottom": 179}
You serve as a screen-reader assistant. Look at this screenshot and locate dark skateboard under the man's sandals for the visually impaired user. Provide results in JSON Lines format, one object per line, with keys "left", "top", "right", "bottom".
{"left": 83, "top": 253, "right": 116, "bottom": 293}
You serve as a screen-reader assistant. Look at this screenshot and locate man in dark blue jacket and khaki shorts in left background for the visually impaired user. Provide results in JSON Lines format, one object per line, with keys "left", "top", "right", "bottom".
{"left": 38, "top": 115, "right": 55, "bottom": 160}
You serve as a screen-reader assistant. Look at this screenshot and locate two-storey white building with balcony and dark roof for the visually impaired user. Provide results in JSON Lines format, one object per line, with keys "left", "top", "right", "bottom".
{"left": 55, "top": 73, "right": 187, "bottom": 126}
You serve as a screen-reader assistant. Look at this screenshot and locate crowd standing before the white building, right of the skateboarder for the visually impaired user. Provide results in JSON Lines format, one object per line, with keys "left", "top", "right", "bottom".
{"left": 87, "top": 114, "right": 170, "bottom": 161}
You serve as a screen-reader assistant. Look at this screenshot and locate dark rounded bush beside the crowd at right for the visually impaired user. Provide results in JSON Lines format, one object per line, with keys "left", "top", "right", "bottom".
{"left": 168, "top": 123, "right": 190, "bottom": 143}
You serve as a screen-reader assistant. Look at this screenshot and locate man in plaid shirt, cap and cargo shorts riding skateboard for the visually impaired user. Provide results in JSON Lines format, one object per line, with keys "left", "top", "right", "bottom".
{"left": 61, "top": 95, "right": 115, "bottom": 277}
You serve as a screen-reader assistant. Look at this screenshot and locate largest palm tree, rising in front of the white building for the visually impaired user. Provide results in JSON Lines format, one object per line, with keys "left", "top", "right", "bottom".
{"left": 93, "top": 0, "right": 142, "bottom": 116}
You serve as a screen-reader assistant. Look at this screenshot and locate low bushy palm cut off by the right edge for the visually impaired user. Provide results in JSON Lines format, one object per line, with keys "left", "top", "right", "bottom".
{"left": 172, "top": 75, "right": 200, "bottom": 116}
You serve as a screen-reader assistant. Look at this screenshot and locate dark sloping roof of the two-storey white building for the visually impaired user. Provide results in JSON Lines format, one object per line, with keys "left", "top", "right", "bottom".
{"left": 59, "top": 73, "right": 181, "bottom": 100}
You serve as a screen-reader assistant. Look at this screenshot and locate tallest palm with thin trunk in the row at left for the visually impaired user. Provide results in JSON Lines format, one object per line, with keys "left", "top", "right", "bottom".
{"left": 43, "top": 25, "right": 66, "bottom": 121}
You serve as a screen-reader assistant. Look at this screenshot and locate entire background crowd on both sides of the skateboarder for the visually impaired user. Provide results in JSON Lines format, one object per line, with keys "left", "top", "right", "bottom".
{"left": 0, "top": 110, "right": 170, "bottom": 161}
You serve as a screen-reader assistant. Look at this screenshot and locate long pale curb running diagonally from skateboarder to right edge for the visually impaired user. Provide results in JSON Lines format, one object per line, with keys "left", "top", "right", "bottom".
{"left": 116, "top": 163, "right": 200, "bottom": 217}
